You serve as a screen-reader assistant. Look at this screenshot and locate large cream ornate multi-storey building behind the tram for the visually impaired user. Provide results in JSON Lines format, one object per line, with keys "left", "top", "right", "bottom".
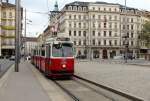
{"left": 50, "top": 2, "right": 149, "bottom": 59}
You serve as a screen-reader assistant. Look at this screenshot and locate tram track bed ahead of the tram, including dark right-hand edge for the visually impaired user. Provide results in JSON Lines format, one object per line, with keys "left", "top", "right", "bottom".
{"left": 54, "top": 75, "right": 144, "bottom": 101}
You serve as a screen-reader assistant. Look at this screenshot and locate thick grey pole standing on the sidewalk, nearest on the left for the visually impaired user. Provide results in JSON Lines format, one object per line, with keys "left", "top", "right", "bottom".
{"left": 15, "top": 0, "right": 20, "bottom": 72}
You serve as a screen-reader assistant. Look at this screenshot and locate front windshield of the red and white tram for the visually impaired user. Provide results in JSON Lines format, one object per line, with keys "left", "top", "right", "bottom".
{"left": 52, "top": 43, "right": 73, "bottom": 57}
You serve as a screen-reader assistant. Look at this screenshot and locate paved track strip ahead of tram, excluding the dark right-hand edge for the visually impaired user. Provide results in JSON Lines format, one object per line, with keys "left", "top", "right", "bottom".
{"left": 54, "top": 79, "right": 127, "bottom": 101}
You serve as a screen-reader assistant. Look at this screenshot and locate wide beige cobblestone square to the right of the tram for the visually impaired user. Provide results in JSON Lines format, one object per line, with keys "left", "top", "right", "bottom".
{"left": 75, "top": 61, "right": 150, "bottom": 101}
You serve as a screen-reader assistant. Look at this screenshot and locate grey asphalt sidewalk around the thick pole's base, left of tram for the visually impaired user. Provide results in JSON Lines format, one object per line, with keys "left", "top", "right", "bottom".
{"left": 0, "top": 62, "right": 51, "bottom": 101}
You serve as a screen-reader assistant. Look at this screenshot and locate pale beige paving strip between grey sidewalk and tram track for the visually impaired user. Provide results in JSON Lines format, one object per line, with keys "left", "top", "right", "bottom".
{"left": 30, "top": 63, "right": 71, "bottom": 101}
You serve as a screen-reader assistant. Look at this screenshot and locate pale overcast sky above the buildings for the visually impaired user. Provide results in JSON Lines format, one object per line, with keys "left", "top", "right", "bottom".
{"left": 9, "top": 0, "right": 150, "bottom": 37}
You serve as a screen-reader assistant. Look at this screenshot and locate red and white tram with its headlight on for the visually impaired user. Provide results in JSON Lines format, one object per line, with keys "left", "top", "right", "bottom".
{"left": 31, "top": 37, "right": 74, "bottom": 76}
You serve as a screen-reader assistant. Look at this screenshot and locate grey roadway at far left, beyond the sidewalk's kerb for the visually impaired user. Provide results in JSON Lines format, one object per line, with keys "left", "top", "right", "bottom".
{"left": 0, "top": 59, "right": 14, "bottom": 77}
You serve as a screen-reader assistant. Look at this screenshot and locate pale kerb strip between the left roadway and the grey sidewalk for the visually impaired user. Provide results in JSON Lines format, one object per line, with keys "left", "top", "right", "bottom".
{"left": 0, "top": 65, "right": 14, "bottom": 89}
